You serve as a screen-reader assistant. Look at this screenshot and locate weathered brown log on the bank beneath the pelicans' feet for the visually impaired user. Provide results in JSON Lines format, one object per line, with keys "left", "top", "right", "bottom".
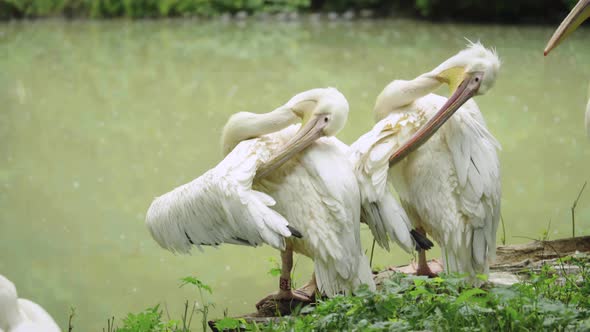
{"left": 209, "top": 236, "right": 590, "bottom": 332}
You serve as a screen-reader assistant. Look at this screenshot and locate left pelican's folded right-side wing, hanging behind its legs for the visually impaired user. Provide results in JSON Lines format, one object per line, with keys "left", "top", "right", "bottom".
{"left": 300, "top": 137, "right": 375, "bottom": 296}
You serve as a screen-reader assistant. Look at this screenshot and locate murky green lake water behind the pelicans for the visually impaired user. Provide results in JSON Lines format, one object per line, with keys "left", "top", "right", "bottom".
{"left": 0, "top": 20, "right": 590, "bottom": 331}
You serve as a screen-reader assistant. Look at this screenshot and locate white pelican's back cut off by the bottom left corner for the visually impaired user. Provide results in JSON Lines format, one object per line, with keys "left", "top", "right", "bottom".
{"left": 0, "top": 275, "right": 60, "bottom": 332}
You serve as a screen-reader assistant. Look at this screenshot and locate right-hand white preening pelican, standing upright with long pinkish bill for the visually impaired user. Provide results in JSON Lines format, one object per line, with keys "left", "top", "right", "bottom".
{"left": 351, "top": 43, "right": 500, "bottom": 276}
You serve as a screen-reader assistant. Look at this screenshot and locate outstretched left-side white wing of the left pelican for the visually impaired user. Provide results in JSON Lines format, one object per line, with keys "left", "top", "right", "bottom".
{"left": 146, "top": 138, "right": 291, "bottom": 253}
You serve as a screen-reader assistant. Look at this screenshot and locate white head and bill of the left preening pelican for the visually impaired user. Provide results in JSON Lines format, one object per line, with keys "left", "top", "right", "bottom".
{"left": 256, "top": 88, "right": 348, "bottom": 178}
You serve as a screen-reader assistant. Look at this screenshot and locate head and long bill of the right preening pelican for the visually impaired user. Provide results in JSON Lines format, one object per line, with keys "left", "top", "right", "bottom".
{"left": 389, "top": 42, "right": 500, "bottom": 165}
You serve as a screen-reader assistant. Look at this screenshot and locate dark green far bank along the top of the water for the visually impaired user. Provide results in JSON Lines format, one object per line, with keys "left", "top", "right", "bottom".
{"left": 0, "top": 0, "right": 575, "bottom": 22}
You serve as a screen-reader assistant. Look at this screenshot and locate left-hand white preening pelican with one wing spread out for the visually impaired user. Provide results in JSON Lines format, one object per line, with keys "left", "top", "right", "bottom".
{"left": 146, "top": 88, "right": 375, "bottom": 302}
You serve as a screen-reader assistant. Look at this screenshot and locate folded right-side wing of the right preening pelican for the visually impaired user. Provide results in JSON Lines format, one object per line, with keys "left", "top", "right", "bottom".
{"left": 445, "top": 107, "right": 501, "bottom": 266}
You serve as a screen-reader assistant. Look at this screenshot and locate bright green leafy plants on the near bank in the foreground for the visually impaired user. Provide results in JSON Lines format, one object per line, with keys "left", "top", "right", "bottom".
{"left": 89, "top": 256, "right": 590, "bottom": 332}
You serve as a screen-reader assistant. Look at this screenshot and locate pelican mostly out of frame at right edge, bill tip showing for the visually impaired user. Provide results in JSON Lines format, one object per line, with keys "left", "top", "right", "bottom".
{"left": 543, "top": 0, "right": 590, "bottom": 137}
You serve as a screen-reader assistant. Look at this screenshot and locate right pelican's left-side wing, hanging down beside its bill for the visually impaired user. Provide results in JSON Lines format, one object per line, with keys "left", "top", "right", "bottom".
{"left": 349, "top": 113, "right": 426, "bottom": 252}
